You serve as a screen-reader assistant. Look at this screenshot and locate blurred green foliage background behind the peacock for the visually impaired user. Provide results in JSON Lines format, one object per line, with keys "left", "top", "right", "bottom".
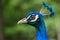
{"left": 2, "top": 0, "right": 60, "bottom": 40}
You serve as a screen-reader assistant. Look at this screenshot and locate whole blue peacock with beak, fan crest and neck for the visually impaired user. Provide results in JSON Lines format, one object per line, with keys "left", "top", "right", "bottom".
{"left": 17, "top": 2, "right": 54, "bottom": 40}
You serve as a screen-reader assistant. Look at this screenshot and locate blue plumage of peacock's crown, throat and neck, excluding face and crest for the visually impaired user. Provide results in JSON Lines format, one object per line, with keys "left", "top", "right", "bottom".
{"left": 27, "top": 11, "right": 48, "bottom": 40}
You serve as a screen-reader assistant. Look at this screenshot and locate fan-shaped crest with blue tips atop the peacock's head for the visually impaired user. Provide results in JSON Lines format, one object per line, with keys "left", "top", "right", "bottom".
{"left": 40, "top": 2, "right": 54, "bottom": 16}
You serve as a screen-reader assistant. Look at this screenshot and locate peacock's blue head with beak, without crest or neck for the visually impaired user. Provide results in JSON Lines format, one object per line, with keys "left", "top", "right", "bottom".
{"left": 17, "top": 11, "right": 41, "bottom": 26}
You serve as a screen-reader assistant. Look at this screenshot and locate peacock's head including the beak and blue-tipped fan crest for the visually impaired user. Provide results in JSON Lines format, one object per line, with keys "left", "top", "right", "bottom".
{"left": 17, "top": 2, "right": 54, "bottom": 26}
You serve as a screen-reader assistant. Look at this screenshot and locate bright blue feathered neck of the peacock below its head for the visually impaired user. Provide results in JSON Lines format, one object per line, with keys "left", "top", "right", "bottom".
{"left": 36, "top": 23, "right": 48, "bottom": 40}
